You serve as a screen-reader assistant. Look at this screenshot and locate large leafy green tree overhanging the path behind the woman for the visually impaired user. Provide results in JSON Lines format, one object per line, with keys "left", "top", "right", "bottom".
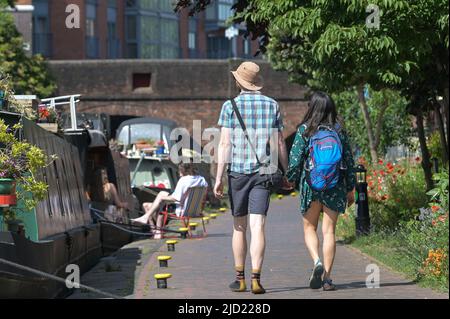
{"left": 178, "top": 0, "right": 448, "bottom": 168}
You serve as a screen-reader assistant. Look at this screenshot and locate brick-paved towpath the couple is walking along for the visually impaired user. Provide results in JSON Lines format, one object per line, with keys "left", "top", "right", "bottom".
{"left": 134, "top": 197, "right": 448, "bottom": 299}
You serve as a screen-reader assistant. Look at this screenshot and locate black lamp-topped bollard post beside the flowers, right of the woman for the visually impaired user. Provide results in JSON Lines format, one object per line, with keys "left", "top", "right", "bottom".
{"left": 355, "top": 165, "right": 370, "bottom": 236}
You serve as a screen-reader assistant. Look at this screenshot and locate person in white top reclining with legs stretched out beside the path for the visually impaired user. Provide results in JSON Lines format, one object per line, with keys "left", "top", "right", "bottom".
{"left": 131, "top": 163, "right": 208, "bottom": 239}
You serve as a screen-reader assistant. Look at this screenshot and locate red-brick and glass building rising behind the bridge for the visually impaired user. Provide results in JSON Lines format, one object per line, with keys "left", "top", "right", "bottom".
{"left": 10, "top": 0, "right": 258, "bottom": 60}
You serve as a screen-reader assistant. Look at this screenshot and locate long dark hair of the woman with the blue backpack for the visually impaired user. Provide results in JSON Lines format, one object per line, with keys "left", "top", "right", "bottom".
{"left": 301, "top": 91, "right": 343, "bottom": 137}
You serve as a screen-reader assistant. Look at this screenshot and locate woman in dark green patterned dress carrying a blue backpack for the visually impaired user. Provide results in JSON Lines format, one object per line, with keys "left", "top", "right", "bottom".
{"left": 287, "top": 92, "right": 356, "bottom": 291}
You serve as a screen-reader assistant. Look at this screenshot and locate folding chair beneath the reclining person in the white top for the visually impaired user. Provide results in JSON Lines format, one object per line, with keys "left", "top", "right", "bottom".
{"left": 161, "top": 187, "right": 207, "bottom": 238}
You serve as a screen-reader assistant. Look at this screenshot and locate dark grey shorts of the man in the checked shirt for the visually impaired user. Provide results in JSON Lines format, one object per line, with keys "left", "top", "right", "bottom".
{"left": 228, "top": 172, "right": 270, "bottom": 217}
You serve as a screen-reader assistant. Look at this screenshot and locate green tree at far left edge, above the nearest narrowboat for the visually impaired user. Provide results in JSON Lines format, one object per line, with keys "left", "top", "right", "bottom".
{"left": 0, "top": 0, "right": 56, "bottom": 98}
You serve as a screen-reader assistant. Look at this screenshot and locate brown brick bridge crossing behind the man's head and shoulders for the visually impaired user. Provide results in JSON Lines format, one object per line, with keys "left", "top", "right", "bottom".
{"left": 50, "top": 60, "right": 307, "bottom": 144}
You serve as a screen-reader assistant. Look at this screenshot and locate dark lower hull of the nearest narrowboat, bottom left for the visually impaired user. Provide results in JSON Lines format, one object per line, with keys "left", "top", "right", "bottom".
{"left": 0, "top": 224, "right": 102, "bottom": 299}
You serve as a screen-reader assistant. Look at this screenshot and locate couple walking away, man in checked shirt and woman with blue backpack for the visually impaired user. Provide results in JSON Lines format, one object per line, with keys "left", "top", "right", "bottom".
{"left": 214, "top": 62, "right": 355, "bottom": 294}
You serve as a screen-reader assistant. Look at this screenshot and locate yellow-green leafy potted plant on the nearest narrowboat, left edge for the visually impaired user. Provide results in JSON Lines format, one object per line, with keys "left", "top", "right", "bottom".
{"left": 0, "top": 119, "right": 56, "bottom": 210}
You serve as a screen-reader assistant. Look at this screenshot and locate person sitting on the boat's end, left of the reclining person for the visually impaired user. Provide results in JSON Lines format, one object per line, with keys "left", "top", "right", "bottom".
{"left": 89, "top": 167, "right": 128, "bottom": 221}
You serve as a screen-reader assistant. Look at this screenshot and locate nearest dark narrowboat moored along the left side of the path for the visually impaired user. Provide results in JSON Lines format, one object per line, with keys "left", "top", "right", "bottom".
{"left": 0, "top": 97, "right": 142, "bottom": 298}
